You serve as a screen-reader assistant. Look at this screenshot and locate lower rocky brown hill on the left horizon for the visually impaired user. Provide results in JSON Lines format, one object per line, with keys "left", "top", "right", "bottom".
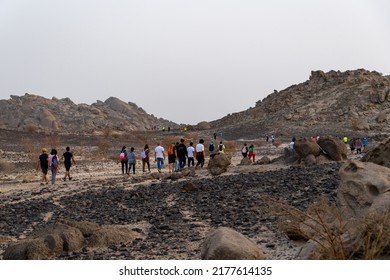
{"left": 0, "top": 93, "right": 177, "bottom": 133}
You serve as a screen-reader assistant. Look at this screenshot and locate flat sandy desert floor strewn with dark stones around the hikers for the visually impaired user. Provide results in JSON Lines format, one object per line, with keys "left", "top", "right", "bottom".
{"left": 0, "top": 131, "right": 380, "bottom": 260}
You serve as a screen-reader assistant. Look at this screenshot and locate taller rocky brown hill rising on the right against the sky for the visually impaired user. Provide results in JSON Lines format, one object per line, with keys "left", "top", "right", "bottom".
{"left": 210, "top": 69, "right": 390, "bottom": 138}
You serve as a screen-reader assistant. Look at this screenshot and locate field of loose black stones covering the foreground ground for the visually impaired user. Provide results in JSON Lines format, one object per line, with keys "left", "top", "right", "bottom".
{"left": 0, "top": 162, "right": 340, "bottom": 259}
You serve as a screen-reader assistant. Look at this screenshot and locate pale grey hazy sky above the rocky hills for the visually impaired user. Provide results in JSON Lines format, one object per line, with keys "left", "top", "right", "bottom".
{"left": 0, "top": 0, "right": 390, "bottom": 124}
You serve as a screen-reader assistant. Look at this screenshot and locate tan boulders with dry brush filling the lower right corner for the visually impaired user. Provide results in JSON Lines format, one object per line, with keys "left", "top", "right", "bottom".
{"left": 294, "top": 138, "right": 390, "bottom": 259}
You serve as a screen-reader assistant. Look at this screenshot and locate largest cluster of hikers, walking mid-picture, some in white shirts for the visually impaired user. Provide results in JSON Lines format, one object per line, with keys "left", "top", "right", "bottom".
{"left": 119, "top": 138, "right": 229, "bottom": 175}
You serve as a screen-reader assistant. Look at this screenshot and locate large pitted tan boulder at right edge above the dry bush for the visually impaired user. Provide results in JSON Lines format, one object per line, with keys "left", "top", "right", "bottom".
{"left": 337, "top": 161, "right": 390, "bottom": 220}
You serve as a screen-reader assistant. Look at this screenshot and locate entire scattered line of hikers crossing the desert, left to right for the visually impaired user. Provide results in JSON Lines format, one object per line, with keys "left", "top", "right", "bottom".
{"left": 36, "top": 133, "right": 368, "bottom": 185}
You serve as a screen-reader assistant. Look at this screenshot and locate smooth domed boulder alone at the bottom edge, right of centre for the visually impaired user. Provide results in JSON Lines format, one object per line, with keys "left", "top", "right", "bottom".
{"left": 201, "top": 227, "right": 266, "bottom": 260}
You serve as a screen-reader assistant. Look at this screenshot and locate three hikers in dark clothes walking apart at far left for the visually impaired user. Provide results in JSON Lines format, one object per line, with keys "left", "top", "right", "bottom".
{"left": 36, "top": 147, "right": 76, "bottom": 185}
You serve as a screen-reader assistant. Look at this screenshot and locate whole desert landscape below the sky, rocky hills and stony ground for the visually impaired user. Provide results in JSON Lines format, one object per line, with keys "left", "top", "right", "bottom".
{"left": 0, "top": 69, "right": 390, "bottom": 259}
